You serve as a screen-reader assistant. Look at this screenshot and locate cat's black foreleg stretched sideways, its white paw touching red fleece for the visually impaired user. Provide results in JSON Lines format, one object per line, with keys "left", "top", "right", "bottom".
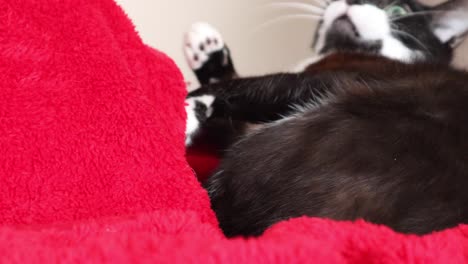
{"left": 186, "top": 74, "right": 331, "bottom": 145}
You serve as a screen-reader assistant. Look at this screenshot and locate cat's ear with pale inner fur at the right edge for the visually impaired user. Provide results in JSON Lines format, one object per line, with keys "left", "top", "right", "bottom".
{"left": 431, "top": 0, "right": 468, "bottom": 46}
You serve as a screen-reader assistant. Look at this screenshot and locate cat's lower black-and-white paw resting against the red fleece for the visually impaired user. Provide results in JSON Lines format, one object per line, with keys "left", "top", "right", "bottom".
{"left": 185, "top": 95, "right": 215, "bottom": 146}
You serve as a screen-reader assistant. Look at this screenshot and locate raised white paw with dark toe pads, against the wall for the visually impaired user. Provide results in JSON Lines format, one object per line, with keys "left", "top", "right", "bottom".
{"left": 184, "top": 22, "right": 224, "bottom": 70}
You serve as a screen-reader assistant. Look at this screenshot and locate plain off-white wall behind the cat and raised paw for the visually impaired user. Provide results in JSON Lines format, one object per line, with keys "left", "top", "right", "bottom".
{"left": 116, "top": 0, "right": 468, "bottom": 87}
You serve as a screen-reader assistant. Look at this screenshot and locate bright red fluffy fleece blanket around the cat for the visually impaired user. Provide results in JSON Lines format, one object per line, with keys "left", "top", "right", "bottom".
{"left": 0, "top": 0, "right": 468, "bottom": 263}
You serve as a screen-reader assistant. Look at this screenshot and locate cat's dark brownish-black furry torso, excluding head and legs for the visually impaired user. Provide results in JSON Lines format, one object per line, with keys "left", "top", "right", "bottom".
{"left": 205, "top": 55, "right": 468, "bottom": 236}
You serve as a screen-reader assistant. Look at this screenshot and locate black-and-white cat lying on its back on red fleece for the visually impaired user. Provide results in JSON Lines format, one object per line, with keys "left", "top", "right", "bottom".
{"left": 182, "top": 0, "right": 468, "bottom": 237}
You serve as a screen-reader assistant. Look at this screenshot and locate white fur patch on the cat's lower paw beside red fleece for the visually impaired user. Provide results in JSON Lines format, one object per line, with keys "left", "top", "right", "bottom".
{"left": 185, "top": 95, "right": 215, "bottom": 146}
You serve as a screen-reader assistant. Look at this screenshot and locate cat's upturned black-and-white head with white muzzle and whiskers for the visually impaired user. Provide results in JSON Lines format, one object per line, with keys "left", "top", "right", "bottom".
{"left": 314, "top": 0, "right": 468, "bottom": 62}
